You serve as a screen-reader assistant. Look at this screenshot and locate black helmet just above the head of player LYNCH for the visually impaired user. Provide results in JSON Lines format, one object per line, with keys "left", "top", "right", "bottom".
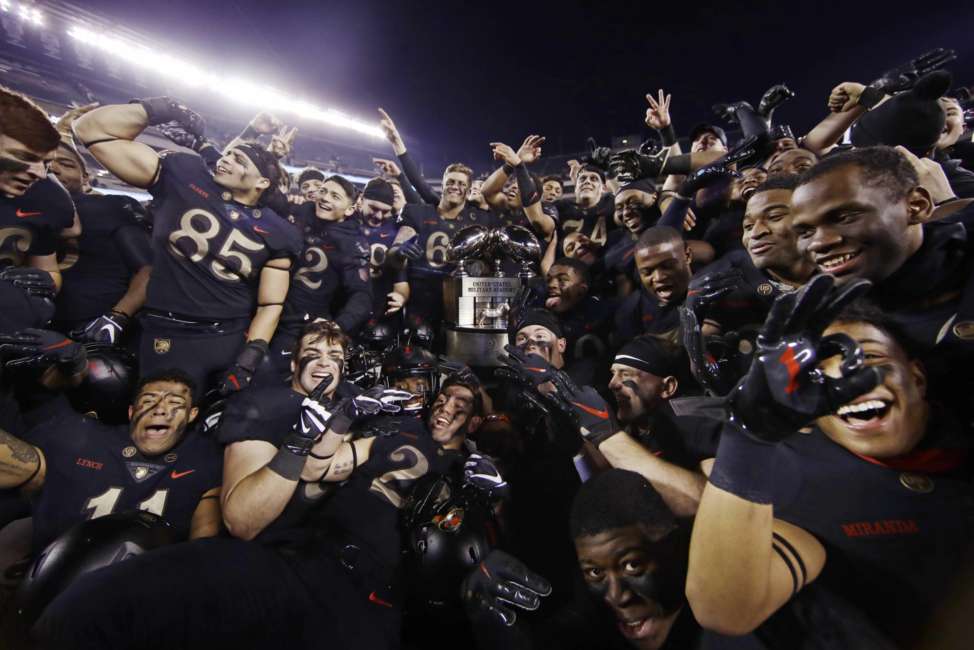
{"left": 66, "top": 343, "right": 139, "bottom": 424}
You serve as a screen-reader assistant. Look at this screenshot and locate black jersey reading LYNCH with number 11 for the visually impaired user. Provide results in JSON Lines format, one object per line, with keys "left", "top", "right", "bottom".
{"left": 31, "top": 414, "right": 223, "bottom": 551}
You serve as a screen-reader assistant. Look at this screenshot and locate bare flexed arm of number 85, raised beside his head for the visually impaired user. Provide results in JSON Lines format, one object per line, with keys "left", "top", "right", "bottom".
{"left": 73, "top": 104, "right": 159, "bottom": 188}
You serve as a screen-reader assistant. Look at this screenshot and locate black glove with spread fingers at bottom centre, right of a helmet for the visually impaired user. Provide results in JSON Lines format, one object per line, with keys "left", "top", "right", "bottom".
{"left": 461, "top": 549, "right": 551, "bottom": 627}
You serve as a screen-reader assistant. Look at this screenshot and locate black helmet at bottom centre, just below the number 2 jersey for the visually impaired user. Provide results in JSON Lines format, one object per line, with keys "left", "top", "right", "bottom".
{"left": 405, "top": 475, "right": 497, "bottom": 609}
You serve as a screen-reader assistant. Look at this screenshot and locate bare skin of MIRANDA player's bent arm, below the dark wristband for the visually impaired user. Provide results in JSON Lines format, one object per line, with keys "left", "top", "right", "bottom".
{"left": 687, "top": 483, "right": 825, "bottom": 635}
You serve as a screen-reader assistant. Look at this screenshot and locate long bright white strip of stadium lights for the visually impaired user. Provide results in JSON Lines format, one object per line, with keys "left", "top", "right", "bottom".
{"left": 65, "top": 24, "right": 385, "bottom": 138}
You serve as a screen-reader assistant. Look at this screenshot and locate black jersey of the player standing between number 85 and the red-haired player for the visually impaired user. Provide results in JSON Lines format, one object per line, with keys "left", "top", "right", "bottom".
{"left": 55, "top": 194, "right": 152, "bottom": 321}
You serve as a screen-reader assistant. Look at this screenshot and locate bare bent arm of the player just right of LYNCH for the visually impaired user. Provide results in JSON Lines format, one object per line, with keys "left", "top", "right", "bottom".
{"left": 220, "top": 440, "right": 298, "bottom": 540}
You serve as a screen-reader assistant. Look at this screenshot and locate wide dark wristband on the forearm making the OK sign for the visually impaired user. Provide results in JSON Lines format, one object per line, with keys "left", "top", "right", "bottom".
{"left": 710, "top": 421, "right": 778, "bottom": 505}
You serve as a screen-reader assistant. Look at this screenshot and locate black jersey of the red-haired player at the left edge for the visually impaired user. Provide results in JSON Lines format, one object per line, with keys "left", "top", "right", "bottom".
{"left": 0, "top": 176, "right": 74, "bottom": 268}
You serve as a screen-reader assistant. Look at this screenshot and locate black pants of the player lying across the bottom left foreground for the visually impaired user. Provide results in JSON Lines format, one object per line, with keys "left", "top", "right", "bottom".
{"left": 34, "top": 538, "right": 400, "bottom": 650}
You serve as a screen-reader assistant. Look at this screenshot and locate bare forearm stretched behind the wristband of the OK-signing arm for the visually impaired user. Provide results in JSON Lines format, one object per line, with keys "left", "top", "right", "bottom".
{"left": 599, "top": 431, "right": 707, "bottom": 517}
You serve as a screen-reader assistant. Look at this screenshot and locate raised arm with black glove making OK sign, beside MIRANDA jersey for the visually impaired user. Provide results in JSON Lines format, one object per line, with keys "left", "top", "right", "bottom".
{"left": 687, "top": 276, "right": 880, "bottom": 635}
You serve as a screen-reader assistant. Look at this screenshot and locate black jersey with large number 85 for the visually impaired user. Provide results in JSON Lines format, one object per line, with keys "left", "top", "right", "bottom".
{"left": 146, "top": 152, "right": 301, "bottom": 320}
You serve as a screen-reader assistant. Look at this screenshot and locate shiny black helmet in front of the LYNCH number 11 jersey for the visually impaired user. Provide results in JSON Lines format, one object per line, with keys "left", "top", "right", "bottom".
{"left": 14, "top": 510, "right": 176, "bottom": 625}
